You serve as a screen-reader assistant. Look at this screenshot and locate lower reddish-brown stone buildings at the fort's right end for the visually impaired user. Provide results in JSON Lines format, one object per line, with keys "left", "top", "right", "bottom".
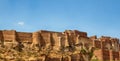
{"left": 90, "top": 36, "right": 120, "bottom": 61}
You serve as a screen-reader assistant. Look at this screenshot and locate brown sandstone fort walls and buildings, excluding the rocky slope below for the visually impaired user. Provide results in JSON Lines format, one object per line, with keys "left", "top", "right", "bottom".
{"left": 0, "top": 30, "right": 120, "bottom": 61}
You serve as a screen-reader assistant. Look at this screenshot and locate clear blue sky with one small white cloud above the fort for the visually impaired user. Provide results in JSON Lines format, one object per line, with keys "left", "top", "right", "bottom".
{"left": 0, "top": 0, "right": 120, "bottom": 38}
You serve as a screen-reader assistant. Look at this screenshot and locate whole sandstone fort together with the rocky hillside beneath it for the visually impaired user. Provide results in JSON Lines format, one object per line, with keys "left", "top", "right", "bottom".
{"left": 0, "top": 30, "right": 120, "bottom": 61}
